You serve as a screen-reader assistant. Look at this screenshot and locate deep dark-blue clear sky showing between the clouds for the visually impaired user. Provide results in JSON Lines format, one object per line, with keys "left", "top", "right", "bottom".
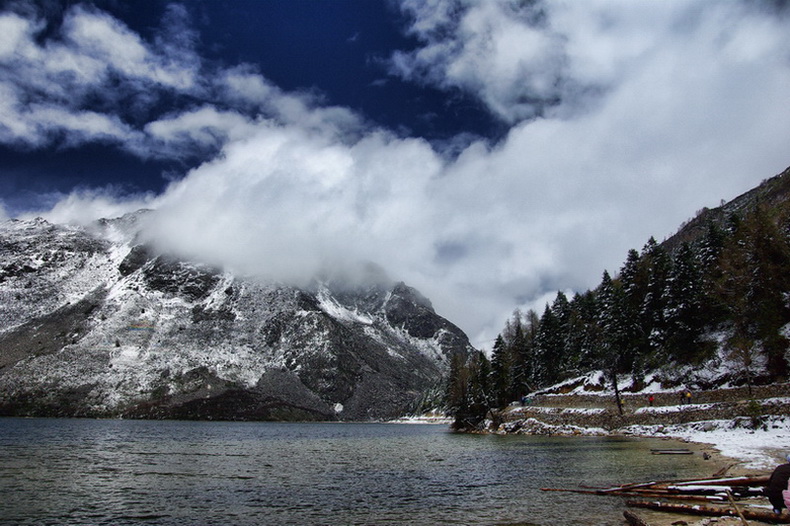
{"left": 0, "top": 0, "right": 506, "bottom": 214}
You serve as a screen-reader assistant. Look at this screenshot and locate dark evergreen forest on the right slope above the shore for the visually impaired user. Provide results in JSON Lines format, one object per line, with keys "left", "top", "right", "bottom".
{"left": 446, "top": 206, "right": 790, "bottom": 427}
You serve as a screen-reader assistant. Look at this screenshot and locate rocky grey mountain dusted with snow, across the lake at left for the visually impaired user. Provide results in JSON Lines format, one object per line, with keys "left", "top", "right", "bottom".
{"left": 0, "top": 211, "right": 473, "bottom": 420}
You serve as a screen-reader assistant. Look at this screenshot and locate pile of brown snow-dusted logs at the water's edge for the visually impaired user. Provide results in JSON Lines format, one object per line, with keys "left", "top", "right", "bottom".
{"left": 541, "top": 475, "right": 790, "bottom": 524}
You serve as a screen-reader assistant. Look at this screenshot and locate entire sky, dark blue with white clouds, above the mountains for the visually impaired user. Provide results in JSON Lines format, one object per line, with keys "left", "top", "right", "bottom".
{"left": 0, "top": 0, "right": 790, "bottom": 348}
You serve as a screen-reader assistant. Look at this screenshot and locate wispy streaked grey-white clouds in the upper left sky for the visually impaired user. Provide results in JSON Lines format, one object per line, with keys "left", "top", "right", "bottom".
{"left": 0, "top": 5, "right": 364, "bottom": 158}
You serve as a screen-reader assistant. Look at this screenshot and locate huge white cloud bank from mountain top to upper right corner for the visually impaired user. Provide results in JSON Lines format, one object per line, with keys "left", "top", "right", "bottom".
{"left": 23, "top": 0, "right": 790, "bottom": 341}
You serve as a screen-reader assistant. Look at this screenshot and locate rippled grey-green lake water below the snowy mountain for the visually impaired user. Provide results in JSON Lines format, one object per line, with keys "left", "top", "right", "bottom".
{"left": 0, "top": 418, "right": 710, "bottom": 526}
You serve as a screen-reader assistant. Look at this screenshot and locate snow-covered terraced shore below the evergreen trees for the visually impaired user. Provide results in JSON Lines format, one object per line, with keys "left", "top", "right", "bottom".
{"left": 496, "top": 374, "right": 790, "bottom": 473}
